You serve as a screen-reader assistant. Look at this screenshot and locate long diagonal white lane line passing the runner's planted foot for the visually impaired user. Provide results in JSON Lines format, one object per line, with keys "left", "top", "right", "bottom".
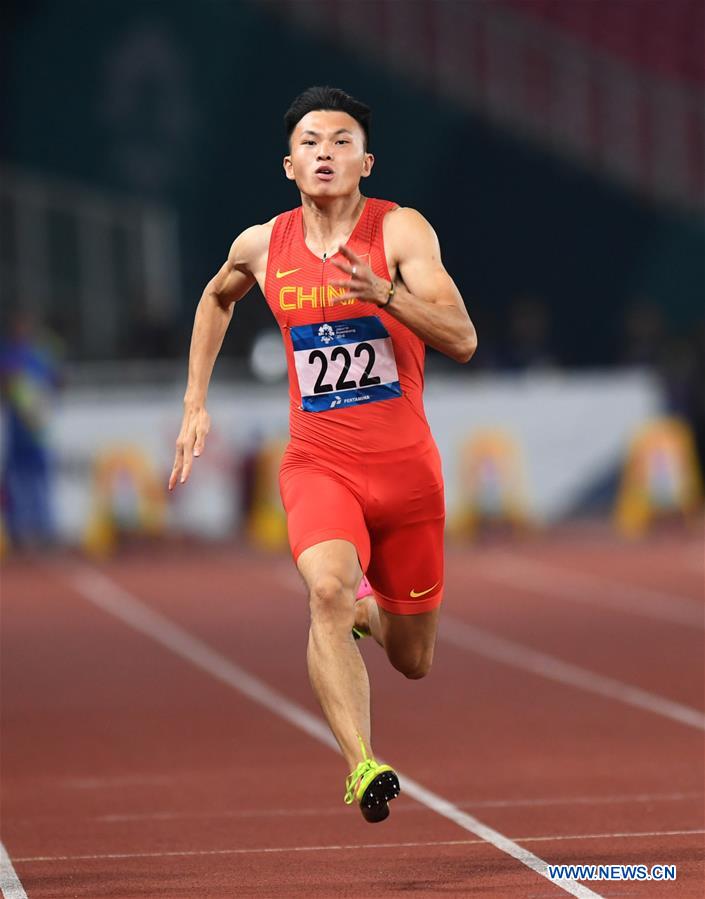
{"left": 70, "top": 567, "right": 599, "bottom": 899}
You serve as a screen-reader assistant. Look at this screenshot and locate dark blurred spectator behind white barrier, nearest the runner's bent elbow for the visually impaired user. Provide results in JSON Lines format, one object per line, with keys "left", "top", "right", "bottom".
{"left": 499, "top": 296, "right": 558, "bottom": 371}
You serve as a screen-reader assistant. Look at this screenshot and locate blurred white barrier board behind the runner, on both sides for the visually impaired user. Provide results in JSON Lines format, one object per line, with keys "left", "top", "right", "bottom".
{"left": 44, "top": 372, "right": 662, "bottom": 540}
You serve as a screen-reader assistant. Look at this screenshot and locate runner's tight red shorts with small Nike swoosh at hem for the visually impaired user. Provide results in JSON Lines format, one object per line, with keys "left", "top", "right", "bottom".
{"left": 279, "top": 437, "right": 445, "bottom": 615}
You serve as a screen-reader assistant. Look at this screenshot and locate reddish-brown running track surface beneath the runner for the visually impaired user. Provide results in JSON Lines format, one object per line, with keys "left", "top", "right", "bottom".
{"left": 0, "top": 536, "right": 705, "bottom": 899}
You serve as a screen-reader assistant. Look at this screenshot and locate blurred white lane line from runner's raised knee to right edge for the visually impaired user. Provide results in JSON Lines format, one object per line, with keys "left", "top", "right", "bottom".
{"left": 439, "top": 614, "right": 705, "bottom": 730}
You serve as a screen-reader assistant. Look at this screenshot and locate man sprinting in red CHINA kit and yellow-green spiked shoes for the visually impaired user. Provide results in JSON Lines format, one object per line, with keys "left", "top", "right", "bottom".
{"left": 169, "top": 87, "right": 477, "bottom": 822}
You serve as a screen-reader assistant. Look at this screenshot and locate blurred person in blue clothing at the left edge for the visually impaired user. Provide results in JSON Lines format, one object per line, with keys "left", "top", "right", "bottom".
{"left": 0, "top": 312, "right": 60, "bottom": 549}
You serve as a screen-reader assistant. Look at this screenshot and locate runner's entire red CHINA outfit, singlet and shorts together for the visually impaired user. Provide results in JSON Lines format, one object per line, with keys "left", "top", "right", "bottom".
{"left": 265, "top": 199, "right": 444, "bottom": 614}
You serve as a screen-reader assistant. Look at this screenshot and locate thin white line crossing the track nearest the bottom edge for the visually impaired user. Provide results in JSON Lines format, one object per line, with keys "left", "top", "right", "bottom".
{"left": 17, "top": 830, "right": 705, "bottom": 864}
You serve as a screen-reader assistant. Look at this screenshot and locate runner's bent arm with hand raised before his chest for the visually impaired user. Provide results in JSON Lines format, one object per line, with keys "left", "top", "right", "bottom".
{"left": 338, "top": 208, "right": 477, "bottom": 362}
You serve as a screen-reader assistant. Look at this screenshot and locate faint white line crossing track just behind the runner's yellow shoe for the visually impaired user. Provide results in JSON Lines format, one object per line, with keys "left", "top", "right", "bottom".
{"left": 89, "top": 793, "right": 705, "bottom": 824}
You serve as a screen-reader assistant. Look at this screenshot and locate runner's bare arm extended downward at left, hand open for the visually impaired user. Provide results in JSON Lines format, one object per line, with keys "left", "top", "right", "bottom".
{"left": 169, "top": 225, "right": 269, "bottom": 490}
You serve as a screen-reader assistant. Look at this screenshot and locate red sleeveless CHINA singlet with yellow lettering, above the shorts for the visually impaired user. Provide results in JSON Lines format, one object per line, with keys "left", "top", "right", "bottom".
{"left": 265, "top": 199, "right": 428, "bottom": 452}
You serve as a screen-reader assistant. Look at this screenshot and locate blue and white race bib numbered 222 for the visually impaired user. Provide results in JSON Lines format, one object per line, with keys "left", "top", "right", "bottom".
{"left": 291, "top": 315, "right": 401, "bottom": 412}
